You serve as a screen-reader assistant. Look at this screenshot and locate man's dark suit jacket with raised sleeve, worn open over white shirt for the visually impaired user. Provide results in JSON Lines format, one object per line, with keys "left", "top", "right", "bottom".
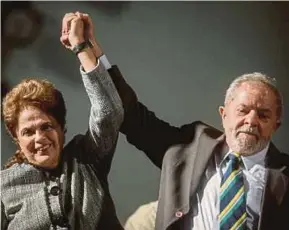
{"left": 109, "top": 66, "right": 289, "bottom": 230}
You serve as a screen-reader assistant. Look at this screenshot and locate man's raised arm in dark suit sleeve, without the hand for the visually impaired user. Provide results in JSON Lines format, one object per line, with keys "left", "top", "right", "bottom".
{"left": 109, "top": 66, "right": 197, "bottom": 168}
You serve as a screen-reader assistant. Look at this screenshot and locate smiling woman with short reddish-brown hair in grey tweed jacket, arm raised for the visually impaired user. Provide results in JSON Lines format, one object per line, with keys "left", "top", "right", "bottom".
{"left": 1, "top": 13, "right": 123, "bottom": 230}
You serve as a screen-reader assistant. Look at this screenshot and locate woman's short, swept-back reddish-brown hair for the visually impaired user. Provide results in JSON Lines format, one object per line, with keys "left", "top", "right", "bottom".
{"left": 2, "top": 79, "right": 66, "bottom": 138}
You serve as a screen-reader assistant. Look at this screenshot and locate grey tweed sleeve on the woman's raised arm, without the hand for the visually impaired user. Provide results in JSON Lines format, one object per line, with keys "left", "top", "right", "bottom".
{"left": 81, "top": 62, "right": 123, "bottom": 154}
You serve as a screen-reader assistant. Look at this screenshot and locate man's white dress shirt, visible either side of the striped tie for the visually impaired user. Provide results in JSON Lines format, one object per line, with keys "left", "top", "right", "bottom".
{"left": 192, "top": 144, "right": 269, "bottom": 230}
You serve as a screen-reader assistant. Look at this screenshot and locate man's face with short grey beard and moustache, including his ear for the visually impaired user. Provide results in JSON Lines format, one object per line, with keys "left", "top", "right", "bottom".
{"left": 219, "top": 81, "right": 279, "bottom": 155}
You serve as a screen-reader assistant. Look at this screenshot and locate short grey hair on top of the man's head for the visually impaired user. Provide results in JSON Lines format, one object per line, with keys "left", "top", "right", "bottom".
{"left": 225, "top": 72, "right": 283, "bottom": 120}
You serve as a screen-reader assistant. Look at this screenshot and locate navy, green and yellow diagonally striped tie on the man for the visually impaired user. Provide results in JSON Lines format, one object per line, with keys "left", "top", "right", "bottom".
{"left": 219, "top": 153, "right": 246, "bottom": 230}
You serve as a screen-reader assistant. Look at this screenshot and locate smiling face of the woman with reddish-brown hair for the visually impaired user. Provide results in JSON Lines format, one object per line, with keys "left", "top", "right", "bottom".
{"left": 16, "top": 106, "right": 64, "bottom": 169}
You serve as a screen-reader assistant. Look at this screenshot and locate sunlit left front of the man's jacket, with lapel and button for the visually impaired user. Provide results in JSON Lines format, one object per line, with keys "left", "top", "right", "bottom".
{"left": 157, "top": 128, "right": 222, "bottom": 230}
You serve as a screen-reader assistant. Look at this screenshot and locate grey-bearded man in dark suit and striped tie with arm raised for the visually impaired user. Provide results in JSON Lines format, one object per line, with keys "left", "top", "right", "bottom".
{"left": 68, "top": 13, "right": 289, "bottom": 230}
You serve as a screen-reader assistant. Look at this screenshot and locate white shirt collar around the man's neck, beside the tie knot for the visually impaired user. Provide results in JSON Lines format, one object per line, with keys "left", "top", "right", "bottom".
{"left": 219, "top": 143, "right": 270, "bottom": 170}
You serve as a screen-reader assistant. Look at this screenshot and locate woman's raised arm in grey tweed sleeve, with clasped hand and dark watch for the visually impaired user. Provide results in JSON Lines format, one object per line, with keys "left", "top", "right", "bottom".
{"left": 61, "top": 14, "right": 123, "bottom": 156}
